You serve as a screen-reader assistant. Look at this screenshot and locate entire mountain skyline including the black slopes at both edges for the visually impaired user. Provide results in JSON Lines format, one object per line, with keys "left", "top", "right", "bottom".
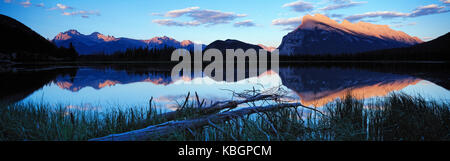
{"left": 0, "top": 14, "right": 449, "bottom": 60}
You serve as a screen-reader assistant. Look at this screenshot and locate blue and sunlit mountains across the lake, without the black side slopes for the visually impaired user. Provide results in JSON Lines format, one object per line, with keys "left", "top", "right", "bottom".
{"left": 52, "top": 14, "right": 438, "bottom": 56}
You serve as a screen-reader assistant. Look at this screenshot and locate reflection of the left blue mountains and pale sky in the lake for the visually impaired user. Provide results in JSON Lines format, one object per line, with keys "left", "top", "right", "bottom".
{"left": 23, "top": 67, "right": 282, "bottom": 110}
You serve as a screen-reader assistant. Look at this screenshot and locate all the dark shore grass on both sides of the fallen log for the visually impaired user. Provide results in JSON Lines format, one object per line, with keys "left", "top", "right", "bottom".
{"left": 0, "top": 93, "right": 450, "bottom": 141}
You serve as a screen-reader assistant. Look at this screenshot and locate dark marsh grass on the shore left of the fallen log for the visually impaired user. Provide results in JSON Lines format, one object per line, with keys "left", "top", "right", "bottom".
{"left": 0, "top": 104, "right": 165, "bottom": 141}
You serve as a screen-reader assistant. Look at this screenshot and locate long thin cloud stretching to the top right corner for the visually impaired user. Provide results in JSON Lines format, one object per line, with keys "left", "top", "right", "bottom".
{"left": 345, "top": 4, "right": 449, "bottom": 21}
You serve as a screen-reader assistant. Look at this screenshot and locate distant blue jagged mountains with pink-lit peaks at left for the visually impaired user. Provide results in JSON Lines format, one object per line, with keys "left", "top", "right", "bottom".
{"left": 52, "top": 30, "right": 204, "bottom": 55}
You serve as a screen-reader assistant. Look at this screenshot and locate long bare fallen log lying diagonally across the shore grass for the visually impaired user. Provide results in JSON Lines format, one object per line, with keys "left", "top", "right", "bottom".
{"left": 89, "top": 103, "right": 317, "bottom": 141}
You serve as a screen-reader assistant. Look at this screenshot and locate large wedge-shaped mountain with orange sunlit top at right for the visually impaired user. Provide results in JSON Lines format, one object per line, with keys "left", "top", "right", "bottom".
{"left": 278, "top": 14, "right": 422, "bottom": 55}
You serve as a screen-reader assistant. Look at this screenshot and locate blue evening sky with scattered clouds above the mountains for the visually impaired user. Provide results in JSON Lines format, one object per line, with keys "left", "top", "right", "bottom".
{"left": 0, "top": 0, "right": 450, "bottom": 47}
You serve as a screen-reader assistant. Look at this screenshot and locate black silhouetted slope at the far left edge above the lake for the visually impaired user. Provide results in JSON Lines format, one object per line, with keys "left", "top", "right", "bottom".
{"left": 0, "top": 14, "right": 77, "bottom": 61}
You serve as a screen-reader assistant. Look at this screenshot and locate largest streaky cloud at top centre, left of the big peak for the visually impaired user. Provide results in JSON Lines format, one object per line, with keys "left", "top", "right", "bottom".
{"left": 152, "top": 7, "right": 247, "bottom": 26}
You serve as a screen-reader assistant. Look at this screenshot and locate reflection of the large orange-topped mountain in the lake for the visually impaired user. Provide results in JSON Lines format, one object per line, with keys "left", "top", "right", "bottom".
{"left": 280, "top": 67, "right": 422, "bottom": 107}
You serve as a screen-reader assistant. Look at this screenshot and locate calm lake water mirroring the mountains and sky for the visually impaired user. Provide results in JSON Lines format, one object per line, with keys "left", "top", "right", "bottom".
{"left": 1, "top": 63, "right": 450, "bottom": 111}
